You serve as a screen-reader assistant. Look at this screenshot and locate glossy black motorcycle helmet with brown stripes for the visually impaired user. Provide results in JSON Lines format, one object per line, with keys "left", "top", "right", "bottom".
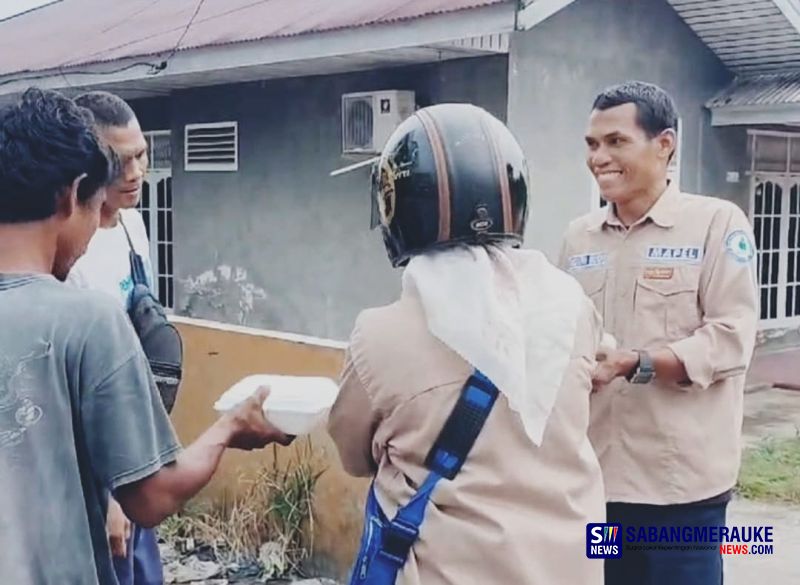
{"left": 372, "top": 104, "right": 529, "bottom": 266}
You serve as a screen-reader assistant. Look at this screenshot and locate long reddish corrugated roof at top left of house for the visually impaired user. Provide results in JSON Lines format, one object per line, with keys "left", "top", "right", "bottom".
{"left": 0, "top": 0, "right": 510, "bottom": 76}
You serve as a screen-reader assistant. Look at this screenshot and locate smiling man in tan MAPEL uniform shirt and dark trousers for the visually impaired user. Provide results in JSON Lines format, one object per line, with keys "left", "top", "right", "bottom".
{"left": 560, "top": 82, "right": 757, "bottom": 585}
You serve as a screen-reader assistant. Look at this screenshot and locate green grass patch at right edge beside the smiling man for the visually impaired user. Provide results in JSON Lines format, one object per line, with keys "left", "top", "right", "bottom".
{"left": 736, "top": 436, "right": 800, "bottom": 504}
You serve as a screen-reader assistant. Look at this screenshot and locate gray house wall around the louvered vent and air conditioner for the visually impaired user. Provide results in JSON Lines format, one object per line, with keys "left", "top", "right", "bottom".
{"left": 148, "top": 55, "right": 508, "bottom": 339}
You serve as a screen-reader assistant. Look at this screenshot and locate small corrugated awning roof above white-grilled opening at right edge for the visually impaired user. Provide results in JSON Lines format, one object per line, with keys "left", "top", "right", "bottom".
{"left": 707, "top": 72, "right": 800, "bottom": 109}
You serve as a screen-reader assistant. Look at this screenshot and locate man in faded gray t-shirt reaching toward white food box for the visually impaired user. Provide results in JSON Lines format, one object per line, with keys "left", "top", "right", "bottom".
{"left": 0, "top": 89, "right": 290, "bottom": 585}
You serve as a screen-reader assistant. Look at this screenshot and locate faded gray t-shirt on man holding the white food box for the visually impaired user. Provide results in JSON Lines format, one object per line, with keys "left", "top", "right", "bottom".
{"left": 0, "top": 274, "right": 180, "bottom": 585}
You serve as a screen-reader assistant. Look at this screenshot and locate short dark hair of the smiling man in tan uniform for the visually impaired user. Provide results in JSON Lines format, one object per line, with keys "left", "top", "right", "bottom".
{"left": 592, "top": 81, "right": 678, "bottom": 138}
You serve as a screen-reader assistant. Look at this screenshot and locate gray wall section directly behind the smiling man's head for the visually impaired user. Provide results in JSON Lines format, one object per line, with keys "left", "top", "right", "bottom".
{"left": 508, "top": 0, "right": 745, "bottom": 254}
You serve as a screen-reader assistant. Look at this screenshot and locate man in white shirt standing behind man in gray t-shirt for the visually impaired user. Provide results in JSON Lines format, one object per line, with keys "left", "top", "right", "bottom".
{"left": 68, "top": 91, "right": 163, "bottom": 585}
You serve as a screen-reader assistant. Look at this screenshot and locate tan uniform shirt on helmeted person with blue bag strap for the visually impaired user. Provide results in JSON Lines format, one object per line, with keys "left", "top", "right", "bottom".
{"left": 329, "top": 296, "right": 605, "bottom": 585}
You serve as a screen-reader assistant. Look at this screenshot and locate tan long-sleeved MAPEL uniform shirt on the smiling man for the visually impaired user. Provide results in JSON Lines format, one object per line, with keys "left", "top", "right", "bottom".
{"left": 559, "top": 184, "right": 757, "bottom": 504}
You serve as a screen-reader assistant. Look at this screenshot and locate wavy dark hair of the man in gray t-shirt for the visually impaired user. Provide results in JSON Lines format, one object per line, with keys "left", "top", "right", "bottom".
{"left": 0, "top": 88, "right": 114, "bottom": 223}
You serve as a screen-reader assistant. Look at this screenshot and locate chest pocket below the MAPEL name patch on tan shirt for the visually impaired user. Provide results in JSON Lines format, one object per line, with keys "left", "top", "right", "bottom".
{"left": 633, "top": 266, "right": 702, "bottom": 346}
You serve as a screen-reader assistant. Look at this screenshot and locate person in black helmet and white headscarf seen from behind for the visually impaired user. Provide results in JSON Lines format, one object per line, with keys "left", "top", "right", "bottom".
{"left": 329, "top": 104, "right": 605, "bottom": 585}
